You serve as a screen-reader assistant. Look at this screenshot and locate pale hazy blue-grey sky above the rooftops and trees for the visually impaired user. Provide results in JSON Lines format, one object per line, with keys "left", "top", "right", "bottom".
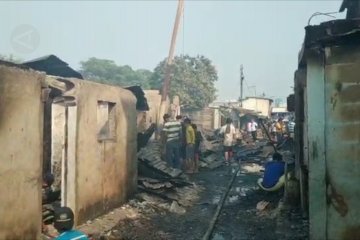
{"left": 0, "top": 0, "right": 344, "bottom": 100}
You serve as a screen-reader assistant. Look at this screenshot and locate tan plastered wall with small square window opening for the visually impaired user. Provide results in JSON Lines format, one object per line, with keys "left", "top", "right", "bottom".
{"left": 64, "top": 80, "right": 137, "bottom": 223}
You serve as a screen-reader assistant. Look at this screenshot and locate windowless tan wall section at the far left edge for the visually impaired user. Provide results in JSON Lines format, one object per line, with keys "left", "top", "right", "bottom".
{"left": 0, "top": 65, "right": 45, "bottom": 239}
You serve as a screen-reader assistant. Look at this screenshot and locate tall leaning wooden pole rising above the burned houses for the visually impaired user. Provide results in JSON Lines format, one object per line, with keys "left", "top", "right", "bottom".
{"left": 158, "top": 0, "right": 184, "bottom": 123}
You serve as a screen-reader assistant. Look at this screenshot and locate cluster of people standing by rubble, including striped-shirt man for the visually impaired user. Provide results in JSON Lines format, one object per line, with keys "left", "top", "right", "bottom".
{"left": 162, "top": 114, "right": 203, "bottom": 173}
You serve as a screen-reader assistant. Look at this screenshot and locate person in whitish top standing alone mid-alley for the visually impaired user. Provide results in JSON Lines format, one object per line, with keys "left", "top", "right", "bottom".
{"left": 220, "top": 118, "right": 236, "bottom": 165}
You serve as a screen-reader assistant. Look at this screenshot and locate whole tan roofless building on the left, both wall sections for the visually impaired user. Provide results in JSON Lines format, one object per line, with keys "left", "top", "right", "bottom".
{"left": 0, "top": 62, "right": 137, "bottom": 239}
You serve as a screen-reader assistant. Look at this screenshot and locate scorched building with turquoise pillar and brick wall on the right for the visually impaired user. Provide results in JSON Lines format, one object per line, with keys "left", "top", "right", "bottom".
{"left": 295, "top": 19, "right": 360, "bottom": 240}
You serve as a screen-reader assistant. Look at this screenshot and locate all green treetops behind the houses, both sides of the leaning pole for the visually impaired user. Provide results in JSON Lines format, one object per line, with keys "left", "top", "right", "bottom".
{"left": 80, "top": 55, "right": 218, "bottom": 109}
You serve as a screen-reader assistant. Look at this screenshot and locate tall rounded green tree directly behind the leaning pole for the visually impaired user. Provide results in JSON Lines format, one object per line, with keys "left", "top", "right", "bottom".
{"left": 150, "top": 55, "right": 218, "bottom": 109}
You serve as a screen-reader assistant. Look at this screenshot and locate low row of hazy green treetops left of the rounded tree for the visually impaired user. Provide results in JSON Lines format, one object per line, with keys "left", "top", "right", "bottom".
{"left": 80, "top": 58, "right": 152, "bottom": 89}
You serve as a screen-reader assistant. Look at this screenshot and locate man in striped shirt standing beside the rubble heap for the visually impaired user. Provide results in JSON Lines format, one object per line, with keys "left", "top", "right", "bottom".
{"left": 163, "top": 114, "right": 181, "bottom": 169}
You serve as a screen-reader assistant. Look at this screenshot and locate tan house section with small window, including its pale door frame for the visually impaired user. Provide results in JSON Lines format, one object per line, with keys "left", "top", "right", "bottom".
{"left": 45, "top": 78, "right": 137, "bottom": 223}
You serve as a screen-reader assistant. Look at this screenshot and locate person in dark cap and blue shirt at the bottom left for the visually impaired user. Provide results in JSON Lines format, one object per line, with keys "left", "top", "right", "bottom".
{"left": 54, "top": 207, "right": 89, "bottom": 240}
